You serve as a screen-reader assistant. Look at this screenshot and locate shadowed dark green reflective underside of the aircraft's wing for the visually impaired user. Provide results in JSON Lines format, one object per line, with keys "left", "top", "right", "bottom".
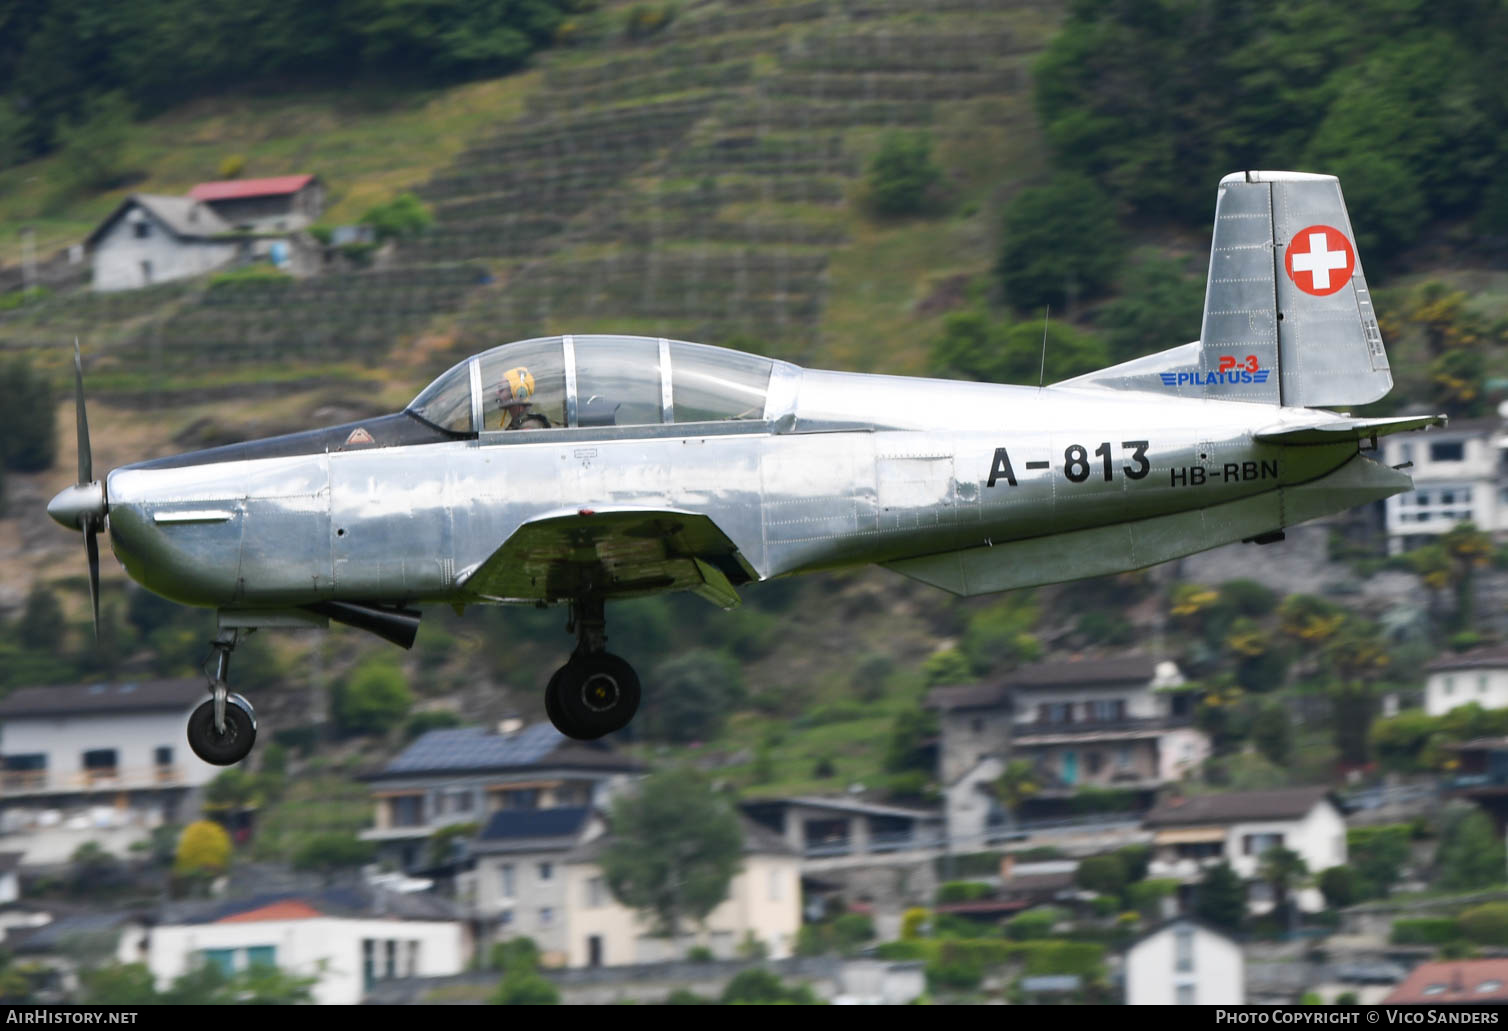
{"left": 455, "top": 508, "right": 747, "bottom": 609}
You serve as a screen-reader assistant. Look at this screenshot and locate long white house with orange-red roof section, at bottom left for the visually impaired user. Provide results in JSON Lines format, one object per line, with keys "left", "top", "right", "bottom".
{"left": 116, "top": 891, "right": 470, "bottom": 1005}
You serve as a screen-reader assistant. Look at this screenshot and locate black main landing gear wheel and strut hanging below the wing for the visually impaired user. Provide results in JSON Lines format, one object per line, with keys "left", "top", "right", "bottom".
{"left": 544, "top": 598, "right": 639, "bottom": 742}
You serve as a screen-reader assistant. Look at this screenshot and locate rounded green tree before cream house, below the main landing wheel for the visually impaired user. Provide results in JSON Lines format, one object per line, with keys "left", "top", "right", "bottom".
{"left": 602, "top": 769, "right": 743, "bottom": 942}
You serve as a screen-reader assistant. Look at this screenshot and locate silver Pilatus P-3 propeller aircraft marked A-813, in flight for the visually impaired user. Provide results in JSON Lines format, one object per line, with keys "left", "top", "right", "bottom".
{"left": 48, "top": 172, "right": 1443, "bottom": 764}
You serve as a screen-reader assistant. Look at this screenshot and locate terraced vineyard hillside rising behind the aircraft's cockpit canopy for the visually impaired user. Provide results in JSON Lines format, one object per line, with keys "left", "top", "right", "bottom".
{"left": 0, "top": 0, "right": 1059, "bottom": 392}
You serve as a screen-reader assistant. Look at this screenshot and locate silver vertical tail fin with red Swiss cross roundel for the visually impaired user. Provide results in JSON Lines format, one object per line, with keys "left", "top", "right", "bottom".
{"left": 1063, "top": 172, "right": 1393, "bottom": 407}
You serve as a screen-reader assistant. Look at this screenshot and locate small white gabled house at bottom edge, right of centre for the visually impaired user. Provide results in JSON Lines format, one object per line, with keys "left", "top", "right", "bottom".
{"left": 1125, "top": 916, "right": 1246, "bottom": 1005}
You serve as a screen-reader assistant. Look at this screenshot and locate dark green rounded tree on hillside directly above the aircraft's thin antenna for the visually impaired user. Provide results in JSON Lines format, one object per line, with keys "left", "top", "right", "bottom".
{"left": 997, "top": 175, "right": 1125, "bottom": 312}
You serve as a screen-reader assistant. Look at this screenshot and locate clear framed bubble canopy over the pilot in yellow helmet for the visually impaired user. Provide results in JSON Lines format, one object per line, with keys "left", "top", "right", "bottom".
{"left": 407, "top": 336, "right": 796, "bottom": 436}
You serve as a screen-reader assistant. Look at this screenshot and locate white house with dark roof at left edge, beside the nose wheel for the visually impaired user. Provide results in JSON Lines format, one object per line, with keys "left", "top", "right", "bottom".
{"left": 0, "top": 680, "right": 220, "bottom": 865}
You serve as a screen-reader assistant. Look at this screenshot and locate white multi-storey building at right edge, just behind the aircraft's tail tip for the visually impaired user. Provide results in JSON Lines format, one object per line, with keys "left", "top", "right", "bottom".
{"left": 1380, "top": 418, "right": 1508, "bottom": 555}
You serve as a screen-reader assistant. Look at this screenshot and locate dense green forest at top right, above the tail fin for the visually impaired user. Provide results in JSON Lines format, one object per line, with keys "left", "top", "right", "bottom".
{"left": 1036, "top": 0, "right": 1508, "bottom": 239}
